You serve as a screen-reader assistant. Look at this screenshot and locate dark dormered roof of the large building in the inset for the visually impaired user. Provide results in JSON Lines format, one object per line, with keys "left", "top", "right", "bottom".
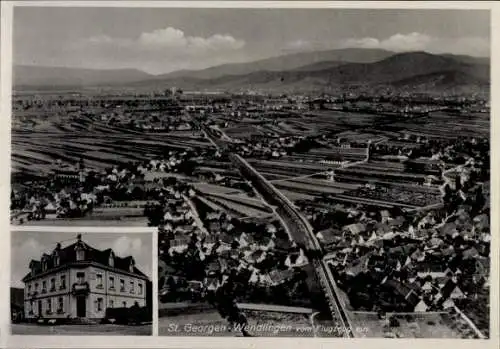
{"left": 23, "top": 235, "right": 147, "bottom": 281}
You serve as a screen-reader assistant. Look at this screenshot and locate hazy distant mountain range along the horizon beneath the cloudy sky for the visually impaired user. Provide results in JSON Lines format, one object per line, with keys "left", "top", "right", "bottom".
{"left": 14, "top": 49, "right": 490, "bottom": 92}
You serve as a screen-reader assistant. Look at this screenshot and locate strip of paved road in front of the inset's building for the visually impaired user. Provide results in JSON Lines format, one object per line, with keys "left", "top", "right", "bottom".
{"left": 12, "top": 324, "right": 152, "bottom": 336}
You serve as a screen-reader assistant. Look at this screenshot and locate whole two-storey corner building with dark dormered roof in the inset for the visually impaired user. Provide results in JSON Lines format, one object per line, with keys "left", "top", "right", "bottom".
{"left": 23, "top": 235, "right": 149, "bottom": 319}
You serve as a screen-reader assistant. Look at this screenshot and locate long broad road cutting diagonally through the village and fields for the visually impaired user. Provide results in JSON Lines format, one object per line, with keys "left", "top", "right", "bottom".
{"left": 204, "top": 123, "right": 355, "bottom": 337}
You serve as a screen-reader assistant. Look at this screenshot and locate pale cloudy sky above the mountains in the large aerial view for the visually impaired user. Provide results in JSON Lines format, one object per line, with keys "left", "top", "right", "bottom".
{"left": 13, "top": 7, "right": 490, "bottom": 74}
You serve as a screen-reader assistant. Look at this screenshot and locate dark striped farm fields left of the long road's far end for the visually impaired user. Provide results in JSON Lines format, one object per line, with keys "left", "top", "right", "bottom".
{"left": 12, "top": 121, "right": 212, "bottom": 174}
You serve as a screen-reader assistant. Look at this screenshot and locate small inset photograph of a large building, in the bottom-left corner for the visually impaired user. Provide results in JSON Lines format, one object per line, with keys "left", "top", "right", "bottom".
{"left": 11, "top": 231, "right": 152, "bottom": 336}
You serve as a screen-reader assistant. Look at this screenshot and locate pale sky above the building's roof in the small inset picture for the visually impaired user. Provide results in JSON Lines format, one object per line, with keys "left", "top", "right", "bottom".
{"left": 10, "top": 231, "right": 153, "bottom": 288}
